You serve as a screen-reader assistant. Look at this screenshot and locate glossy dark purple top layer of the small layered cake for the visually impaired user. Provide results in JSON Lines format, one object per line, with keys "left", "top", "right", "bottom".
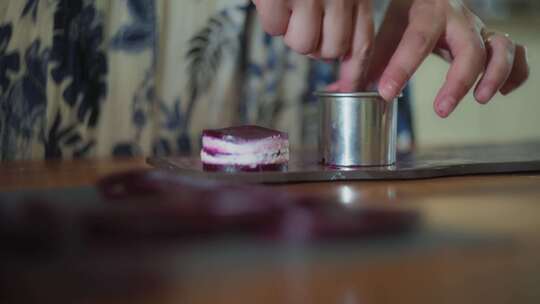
{"left": 203, "top": 125, "right": 289, "bottom": 143}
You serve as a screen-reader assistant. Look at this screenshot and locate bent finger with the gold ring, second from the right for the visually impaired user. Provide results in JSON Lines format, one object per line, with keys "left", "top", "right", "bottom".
{"left": 475, "top": 34, "right": 516, "bottom": 104}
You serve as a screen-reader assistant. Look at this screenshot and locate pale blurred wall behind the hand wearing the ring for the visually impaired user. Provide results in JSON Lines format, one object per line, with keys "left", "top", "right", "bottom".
{"left": 413, "top": 0, "right": 540, "bottom": 147}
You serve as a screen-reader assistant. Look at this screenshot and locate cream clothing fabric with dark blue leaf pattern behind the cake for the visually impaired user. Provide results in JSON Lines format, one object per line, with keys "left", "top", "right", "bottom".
{"left": 0, "top": 0, "right": 412, "bottom": 161}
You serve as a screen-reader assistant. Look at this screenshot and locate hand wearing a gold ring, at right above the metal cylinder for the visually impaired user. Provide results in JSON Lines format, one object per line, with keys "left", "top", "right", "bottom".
{"left": 358, "top": 0, "right": 529, "bottom": 117}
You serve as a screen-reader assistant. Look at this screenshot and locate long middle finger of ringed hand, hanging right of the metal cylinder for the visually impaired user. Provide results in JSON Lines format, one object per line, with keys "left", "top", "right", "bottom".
{"left": 434, "top": 27, "right": 487, "bottom": 118}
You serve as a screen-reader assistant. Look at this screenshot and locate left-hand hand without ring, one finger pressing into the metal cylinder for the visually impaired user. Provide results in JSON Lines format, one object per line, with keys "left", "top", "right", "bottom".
{"left": 253, "top": 0, "right": 375, "bottom": 92}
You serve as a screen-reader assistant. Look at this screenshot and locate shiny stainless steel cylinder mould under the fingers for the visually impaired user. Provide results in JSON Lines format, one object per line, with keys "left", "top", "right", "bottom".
{"left": 315, "top": 92, "right": 397, "bottom": 167}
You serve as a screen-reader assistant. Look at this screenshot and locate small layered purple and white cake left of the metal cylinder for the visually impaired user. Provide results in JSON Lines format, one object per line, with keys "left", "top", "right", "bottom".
{"left": 201, "top": 126, "right": 289, "bottom": 172}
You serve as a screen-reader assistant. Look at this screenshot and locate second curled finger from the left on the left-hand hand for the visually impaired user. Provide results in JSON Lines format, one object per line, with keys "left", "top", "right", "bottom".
{"left": 284, "top": 1, "right": 323, "bottom": 55}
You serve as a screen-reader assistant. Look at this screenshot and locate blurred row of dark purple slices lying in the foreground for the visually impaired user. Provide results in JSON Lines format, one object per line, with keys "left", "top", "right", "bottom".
{"left": 95, "top": 170, "right": 421, "bottom": 244}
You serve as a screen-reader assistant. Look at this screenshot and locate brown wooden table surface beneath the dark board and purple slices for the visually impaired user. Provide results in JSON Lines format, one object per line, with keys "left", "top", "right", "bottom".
{"left": 0, "top": 159, "right": 540, "bottom": 304}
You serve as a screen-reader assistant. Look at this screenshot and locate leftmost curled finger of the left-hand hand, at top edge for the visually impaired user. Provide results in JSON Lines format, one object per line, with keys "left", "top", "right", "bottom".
{"left": 253, "top": 0, "right": 291, "bottom": 36}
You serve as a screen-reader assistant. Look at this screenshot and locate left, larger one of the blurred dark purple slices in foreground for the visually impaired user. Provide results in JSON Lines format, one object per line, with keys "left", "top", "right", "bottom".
{"left": 96, "top": 171, "right": 293, "bottom": 239}
